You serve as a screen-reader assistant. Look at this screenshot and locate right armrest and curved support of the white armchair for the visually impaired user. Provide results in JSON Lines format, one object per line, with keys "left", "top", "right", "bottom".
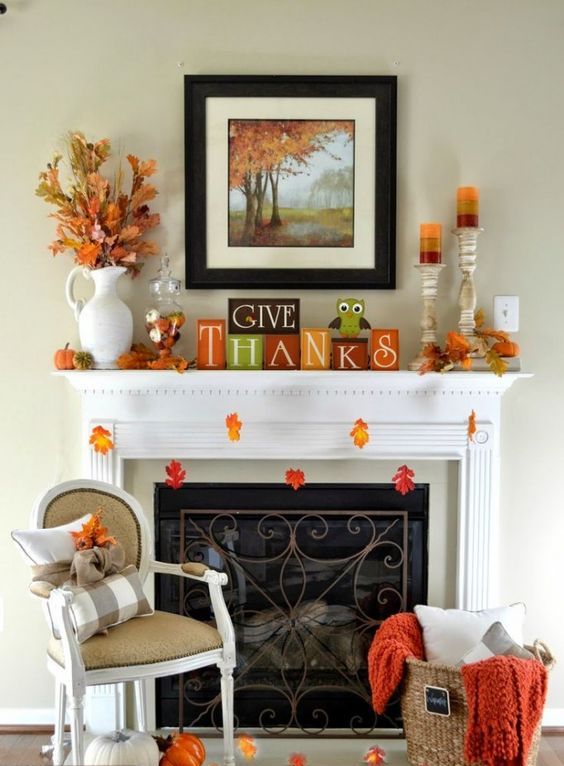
{"left": 149, "top": 561, "right": 235, "bottom": 667}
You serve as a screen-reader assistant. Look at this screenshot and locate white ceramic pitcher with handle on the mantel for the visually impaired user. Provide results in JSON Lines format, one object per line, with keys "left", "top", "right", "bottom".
{"left": 65, "top": 266, "right": 133, "bottom": 370}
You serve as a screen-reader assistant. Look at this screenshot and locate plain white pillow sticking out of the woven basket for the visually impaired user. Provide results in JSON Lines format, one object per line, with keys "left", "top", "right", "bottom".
{"left": 415, "top": 603, "right": 525, "bottom": 665}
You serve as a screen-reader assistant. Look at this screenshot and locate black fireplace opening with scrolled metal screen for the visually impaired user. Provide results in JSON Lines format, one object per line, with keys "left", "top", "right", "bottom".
{"left": 155, "top": 484, "right": 429, "bottom": 735}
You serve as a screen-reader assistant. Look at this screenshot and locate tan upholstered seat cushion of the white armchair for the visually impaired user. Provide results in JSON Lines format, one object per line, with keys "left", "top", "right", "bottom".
{"left": 47, "top": 612, "right": 222, "bottom": 670}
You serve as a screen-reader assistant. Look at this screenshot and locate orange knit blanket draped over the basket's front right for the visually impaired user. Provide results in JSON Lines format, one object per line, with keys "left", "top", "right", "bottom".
{"left": 462, "top": 657, "right": 547, "bottom": 766}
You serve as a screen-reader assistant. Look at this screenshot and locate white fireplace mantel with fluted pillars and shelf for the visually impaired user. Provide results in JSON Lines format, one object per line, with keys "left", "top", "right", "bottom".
{"left": 54, "top": 370, "right": 530, "bottom": 609}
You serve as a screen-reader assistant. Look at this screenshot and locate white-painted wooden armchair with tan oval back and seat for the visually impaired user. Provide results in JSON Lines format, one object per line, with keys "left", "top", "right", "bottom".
{"left": 26, "top": 480, "right": 235, "bottom": 766}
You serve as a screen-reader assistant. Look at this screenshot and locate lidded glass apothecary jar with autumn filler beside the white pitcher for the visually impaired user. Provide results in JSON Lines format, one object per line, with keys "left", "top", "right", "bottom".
{"left": 145, "top": 255, "right": 186, "bottom": 356}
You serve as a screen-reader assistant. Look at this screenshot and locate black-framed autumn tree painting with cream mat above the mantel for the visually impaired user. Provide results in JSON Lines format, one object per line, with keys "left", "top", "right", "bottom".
{"left": 185, "top": 75, "right": 396, "bottom": 290}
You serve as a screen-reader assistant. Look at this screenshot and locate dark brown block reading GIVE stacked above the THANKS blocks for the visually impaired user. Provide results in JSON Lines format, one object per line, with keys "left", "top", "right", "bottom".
{"left": 227, "top": 298, "right": 300, "bottom": 335}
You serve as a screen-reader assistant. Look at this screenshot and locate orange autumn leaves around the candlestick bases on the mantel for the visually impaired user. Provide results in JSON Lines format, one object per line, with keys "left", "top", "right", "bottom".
{"left": 419, "top": 309, "right": 519, "bottom": 377}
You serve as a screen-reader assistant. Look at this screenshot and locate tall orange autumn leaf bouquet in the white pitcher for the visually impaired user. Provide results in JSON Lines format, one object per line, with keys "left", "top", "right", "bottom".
{"left": 35, "top": 131, "right": 160, "bottom": 276}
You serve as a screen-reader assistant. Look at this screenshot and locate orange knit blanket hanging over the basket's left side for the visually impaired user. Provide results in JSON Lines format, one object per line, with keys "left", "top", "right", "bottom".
{"left": 368, "top": 612, "right": 425, "bottom": 714}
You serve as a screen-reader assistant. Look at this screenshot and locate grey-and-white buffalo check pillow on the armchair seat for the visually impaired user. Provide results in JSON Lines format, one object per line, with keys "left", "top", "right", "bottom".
{"left": 63, "top": 565, "right": 153, "bottom": 644}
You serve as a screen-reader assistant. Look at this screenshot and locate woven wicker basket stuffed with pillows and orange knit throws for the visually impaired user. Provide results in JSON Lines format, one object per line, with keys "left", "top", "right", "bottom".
{"left": 401, "top": 641, "right": 554, "bottom": 766}
